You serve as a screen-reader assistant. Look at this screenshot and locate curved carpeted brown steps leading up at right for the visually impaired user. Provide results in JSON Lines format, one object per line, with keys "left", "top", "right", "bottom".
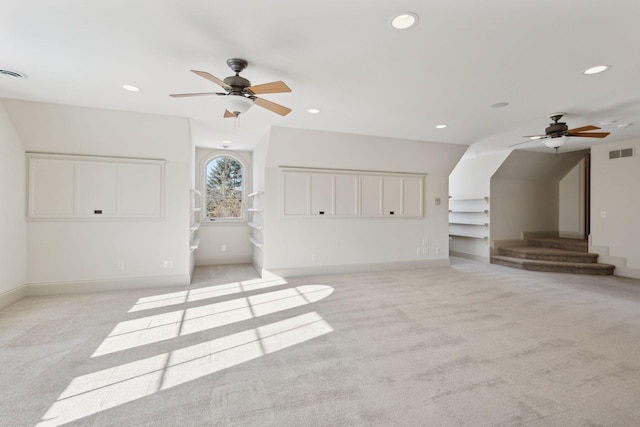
{"left": 491, "top": 238, "right": 615, "bottom": 276}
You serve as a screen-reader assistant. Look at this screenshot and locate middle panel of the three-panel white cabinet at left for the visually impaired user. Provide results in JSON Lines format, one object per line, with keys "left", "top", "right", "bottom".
{"left": 76, "top": 162, "right": 118, "bottom": 217}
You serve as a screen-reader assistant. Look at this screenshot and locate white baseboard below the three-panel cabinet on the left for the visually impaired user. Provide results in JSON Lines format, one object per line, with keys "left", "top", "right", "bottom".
{"left": 25, "top": 274, "right": 191, "bottom": 296}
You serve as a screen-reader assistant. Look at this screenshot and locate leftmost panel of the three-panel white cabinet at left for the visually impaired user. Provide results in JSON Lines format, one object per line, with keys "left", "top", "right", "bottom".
{"left": 29, "top": 159, "right": 75, "bottom": 218}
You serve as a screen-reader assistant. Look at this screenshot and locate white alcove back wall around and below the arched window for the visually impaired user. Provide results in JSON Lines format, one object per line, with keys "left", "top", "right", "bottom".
{"left": 194, "top": 148, "right": 253, "bottom": 265}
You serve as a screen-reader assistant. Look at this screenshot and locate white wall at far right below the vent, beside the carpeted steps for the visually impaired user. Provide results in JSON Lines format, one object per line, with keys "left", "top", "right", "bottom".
{"left": 590, "top": 140, "right": 640, "bottom": 278}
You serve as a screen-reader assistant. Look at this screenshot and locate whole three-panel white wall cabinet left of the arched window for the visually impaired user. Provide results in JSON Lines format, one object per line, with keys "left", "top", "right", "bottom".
{"left": 27, "top": 153, "right": 164, "bottom": 220}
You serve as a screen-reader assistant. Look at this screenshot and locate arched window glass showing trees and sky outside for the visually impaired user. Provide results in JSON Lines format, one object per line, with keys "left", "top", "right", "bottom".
{"left": 206, "top": 157, "right": 243, "bottom": 218}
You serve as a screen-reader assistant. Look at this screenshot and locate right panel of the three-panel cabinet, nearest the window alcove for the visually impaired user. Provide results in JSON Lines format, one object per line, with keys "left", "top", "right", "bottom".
{"left": 118, "top": 165, "right": 162, "bottom": 217}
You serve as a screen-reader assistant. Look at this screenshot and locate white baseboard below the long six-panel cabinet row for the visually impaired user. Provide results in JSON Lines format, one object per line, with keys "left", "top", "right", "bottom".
{"left": 262, "top": 258, "right": 451, "bottom": 278}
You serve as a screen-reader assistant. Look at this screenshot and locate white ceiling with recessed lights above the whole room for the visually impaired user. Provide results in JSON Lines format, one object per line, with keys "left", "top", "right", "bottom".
{"left": 0, "top": 0, "right": 640, "bottom": 152}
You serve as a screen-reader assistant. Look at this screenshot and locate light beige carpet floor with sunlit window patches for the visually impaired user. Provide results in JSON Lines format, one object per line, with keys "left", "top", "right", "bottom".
{"left": 0, "top": 259, "right": 640, "bottom": 427}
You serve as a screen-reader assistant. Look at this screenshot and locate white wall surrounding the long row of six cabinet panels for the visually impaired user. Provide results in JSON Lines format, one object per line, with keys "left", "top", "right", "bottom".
{"left": 264, "top": 128, "right": 467, "bottom": 274}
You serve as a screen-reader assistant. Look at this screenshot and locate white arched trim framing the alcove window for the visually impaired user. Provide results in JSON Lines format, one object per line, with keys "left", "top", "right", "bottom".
{"left": 197, "top": 150, "right": 252, "bottom": 225}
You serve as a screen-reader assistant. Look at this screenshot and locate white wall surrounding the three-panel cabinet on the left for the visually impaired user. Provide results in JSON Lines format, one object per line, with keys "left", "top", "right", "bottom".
{"left": 5, "top": 100, "right": 191, "bottom": 292}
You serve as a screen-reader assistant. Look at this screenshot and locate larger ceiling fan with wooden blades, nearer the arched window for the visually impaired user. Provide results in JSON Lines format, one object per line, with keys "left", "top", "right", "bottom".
{"left": 169, "top": 58, "right": 291, "bottom": 118}
